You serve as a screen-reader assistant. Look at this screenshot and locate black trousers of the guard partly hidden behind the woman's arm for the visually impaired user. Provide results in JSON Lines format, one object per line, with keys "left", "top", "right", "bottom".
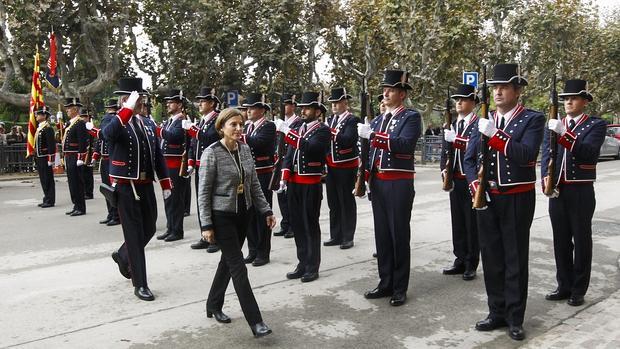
{"left": 248, "top": 173, "right": 273, "bottom": 259}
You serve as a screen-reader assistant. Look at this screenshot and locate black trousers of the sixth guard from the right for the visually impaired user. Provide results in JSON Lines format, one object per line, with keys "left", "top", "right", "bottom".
{"left": 287, "top": 183, "right": 323, "bottom": 273}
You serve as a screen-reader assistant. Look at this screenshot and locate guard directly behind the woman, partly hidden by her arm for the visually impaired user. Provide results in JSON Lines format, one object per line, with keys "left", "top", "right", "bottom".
{"left": 241, "top": 93, "right": 276, "bottom": 267}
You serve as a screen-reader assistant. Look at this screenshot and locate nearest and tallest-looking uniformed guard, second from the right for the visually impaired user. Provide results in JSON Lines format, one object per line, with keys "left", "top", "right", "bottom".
{"left": 463, "top": 64, "right": 545, "bottom": 340}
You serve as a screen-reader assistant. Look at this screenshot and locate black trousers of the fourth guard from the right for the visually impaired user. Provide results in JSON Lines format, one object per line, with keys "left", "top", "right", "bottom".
{"left": 370, "top": 178, "right": 415, "bottom": 294}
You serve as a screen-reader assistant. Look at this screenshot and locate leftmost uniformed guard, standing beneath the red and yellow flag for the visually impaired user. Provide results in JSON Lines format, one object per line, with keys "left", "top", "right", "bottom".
{"left": 34, "top": 106, "right": 56, "bottom": 208}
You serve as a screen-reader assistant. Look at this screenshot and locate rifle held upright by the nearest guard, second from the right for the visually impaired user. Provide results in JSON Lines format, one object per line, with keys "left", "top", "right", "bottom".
{"left": 472, "top": 66, "right": 489, "bottom": 210}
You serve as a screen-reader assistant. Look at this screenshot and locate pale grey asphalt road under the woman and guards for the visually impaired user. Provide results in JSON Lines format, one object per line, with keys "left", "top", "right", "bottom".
{"left": 0, "top": 161, "right": 620, "bottom": 348}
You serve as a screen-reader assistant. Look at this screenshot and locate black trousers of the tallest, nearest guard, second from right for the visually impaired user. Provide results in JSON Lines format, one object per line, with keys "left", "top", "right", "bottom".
{"left": 477, "top": 190, "right": 536, "bottom": 326}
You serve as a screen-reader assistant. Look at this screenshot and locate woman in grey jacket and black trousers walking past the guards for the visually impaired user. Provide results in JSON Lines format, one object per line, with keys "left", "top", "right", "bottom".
{"left": 198, "top": 108, "right": 276, "bottom": 337}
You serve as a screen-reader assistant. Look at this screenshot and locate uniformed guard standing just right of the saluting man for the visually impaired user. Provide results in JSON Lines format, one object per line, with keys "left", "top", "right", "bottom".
{"left": 157, "top": 89, "right": 188, "bottom": 242}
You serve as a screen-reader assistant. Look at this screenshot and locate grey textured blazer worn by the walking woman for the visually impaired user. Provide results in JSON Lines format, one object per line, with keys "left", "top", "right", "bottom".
{"left": 198, "top": 141, "right": 273, "bottom": 230}
